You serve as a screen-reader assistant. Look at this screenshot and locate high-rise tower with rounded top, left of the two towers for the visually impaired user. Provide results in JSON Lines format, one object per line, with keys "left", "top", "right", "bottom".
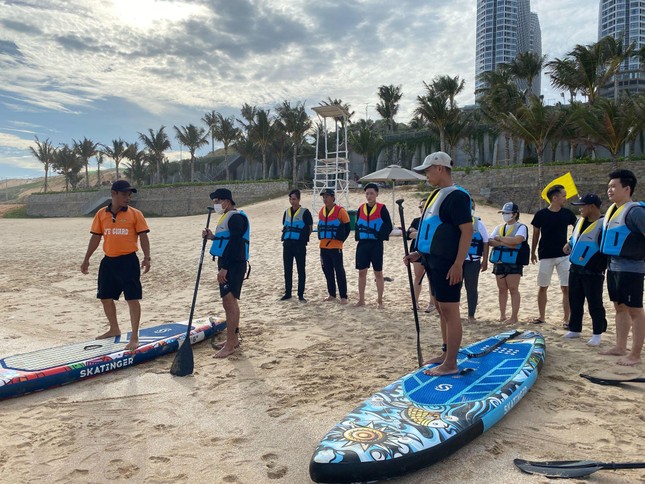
{"left": 475, "top": 0, "right": 542, "bottom": 96}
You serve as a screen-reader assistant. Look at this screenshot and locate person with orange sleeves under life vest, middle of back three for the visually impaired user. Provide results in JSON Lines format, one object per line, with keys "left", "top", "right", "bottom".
{"left": 318, "top": 188, "right": 350, "bottom": 304}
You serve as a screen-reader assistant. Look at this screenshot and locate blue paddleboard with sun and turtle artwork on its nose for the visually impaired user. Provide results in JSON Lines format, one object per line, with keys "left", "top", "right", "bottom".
{"left": 309, "top": 331, "right": 545, "bottom": 482}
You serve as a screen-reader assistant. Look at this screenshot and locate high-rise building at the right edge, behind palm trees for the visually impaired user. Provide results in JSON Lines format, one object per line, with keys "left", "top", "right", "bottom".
{"left": 598, "top": 0, "right": 645, "bottom": 97}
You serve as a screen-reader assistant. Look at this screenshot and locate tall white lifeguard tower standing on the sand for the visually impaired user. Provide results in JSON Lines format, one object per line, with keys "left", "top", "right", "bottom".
{"left": 312, "top": 104, "right": 349, "bottom": 213}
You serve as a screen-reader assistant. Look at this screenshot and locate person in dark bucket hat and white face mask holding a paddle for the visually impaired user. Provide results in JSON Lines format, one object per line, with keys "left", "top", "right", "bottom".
{"left": 202, "top": 188, "right": 250, "bottom": 358}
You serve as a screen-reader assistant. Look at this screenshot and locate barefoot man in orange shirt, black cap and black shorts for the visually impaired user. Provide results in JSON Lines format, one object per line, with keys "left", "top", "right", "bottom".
{"left": 81, "top": 180, "right": 150, "bottom": 351}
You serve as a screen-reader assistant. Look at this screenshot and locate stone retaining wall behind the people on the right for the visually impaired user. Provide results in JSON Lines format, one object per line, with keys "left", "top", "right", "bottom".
{"left": 453, "top": 160, "right": 645, "bottom": 213}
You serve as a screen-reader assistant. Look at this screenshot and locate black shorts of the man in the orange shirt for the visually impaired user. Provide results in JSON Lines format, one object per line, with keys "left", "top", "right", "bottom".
{"left": 96, "top": 252, "right": 143, "bottom": 301}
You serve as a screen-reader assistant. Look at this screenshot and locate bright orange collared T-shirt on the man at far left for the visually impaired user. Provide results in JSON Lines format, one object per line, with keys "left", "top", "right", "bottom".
{"left": 90, "top": 205, "right": 150, "bottom": 257}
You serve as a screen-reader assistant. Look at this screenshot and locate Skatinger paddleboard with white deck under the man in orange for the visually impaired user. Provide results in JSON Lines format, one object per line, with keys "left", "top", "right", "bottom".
{"left": 0, "top": 318, "right": 226, "bottom": 399}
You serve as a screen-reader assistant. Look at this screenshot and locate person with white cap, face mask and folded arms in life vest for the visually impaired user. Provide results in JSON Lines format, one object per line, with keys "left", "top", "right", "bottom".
{"left": 488, "top": 202, "right": 528, "bottom": 324}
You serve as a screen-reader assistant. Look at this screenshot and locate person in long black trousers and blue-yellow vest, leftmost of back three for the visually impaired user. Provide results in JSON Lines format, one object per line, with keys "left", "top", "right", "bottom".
{"left": 280, "top": 189, "right": 314, "bottom": 303}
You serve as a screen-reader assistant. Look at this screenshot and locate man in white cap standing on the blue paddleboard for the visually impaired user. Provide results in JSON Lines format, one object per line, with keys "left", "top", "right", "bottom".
{"left": 403, "top": 151, "right": 473, "bottom": 375}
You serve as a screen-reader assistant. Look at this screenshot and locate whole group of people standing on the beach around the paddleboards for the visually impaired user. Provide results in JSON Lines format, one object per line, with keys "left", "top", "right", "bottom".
{"left": 81, "top": 159, "right": 645, "bottom": 366}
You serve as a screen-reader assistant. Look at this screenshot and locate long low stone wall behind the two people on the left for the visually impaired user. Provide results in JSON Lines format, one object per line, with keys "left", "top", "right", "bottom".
{"left": 27, "top": 181, "right": 289, "bottom": 217}
